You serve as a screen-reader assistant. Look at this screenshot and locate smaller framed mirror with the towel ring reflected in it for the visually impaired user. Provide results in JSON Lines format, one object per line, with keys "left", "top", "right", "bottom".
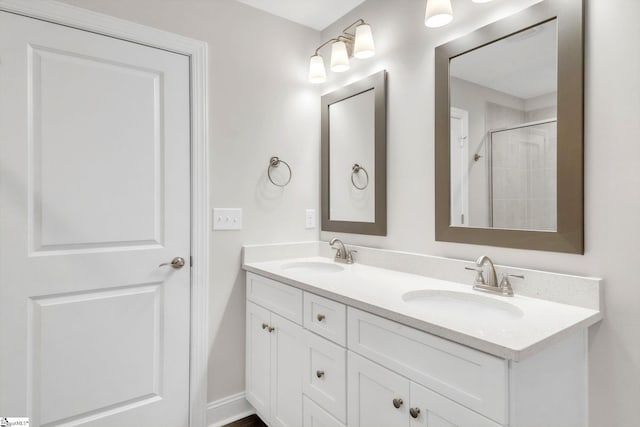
{"left": 321, "top": 71, "right": 387, "bottom": 235}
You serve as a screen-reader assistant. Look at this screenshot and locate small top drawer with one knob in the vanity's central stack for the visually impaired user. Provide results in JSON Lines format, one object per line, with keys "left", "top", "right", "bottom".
{"left": 304, "top": 292, "right": 347, "bottom": 346}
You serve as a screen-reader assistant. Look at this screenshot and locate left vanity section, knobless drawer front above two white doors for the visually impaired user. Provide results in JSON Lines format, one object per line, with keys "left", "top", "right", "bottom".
{"left": 246, "top": 276, "right": 303, "bottom": 427}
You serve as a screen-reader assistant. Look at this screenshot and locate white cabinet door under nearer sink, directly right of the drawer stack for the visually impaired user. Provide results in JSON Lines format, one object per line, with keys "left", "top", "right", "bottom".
{"left": 347, "top": 351, "right": 410, "bottom": 427}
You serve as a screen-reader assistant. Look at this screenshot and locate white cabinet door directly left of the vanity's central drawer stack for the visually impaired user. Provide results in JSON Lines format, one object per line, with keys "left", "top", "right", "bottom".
{"left": 270, "top": 313, "right": 303, "bottom": 427}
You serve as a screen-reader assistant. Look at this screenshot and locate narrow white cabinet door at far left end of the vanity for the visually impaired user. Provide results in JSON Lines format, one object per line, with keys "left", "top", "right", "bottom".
{"left": 246, "top": 301, "right": 272, "bottom": 419}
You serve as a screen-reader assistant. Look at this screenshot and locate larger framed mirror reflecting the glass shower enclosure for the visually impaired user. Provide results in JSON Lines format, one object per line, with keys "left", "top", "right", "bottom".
{"left": 436, "top": 0, "right": 583, "bottom": 253}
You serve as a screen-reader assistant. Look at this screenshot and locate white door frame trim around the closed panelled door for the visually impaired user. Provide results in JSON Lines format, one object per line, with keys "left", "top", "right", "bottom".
{"left": 0, "top": 0, "right": 209, "bottom": 427}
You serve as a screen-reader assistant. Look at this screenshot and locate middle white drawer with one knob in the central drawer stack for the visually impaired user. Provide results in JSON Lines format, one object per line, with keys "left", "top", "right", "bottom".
{"left": 302, "top": 331, "right": 347, "bottom": 422}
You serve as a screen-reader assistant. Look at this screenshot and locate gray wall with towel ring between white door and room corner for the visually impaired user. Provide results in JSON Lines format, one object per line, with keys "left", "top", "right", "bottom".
{"left": 58, "top": 0, "right": 320, "bottom": 401}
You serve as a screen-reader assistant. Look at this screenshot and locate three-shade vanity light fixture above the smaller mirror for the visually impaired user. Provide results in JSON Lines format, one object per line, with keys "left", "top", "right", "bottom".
{"left": 309, "top": 19, "right": 376, "bottom": 84}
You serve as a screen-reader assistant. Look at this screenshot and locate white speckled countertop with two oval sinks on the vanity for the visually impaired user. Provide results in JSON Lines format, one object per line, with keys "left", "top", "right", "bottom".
{"left": 243, "top": 257, "right": 602, "bottom": 361}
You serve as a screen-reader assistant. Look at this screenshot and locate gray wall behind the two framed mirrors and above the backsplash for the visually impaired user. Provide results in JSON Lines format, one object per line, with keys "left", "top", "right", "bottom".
{"left": 321, "top": 0, "right": 640, "bottom": 427}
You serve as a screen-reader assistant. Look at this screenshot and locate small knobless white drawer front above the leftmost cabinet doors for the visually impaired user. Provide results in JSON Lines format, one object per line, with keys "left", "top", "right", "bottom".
{"left": 247, "top": 273, "right": 302, "bottom": 325}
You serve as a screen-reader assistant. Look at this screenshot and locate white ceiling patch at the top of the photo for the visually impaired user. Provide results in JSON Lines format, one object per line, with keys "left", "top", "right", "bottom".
{"left": 238, "top": 0, "right": 365, "bottom": 31}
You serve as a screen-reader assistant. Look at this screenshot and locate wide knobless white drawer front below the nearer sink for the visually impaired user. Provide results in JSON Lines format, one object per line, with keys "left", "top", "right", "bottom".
{"left": 347, "top": 307, "right": 508, "bottom": 424}
